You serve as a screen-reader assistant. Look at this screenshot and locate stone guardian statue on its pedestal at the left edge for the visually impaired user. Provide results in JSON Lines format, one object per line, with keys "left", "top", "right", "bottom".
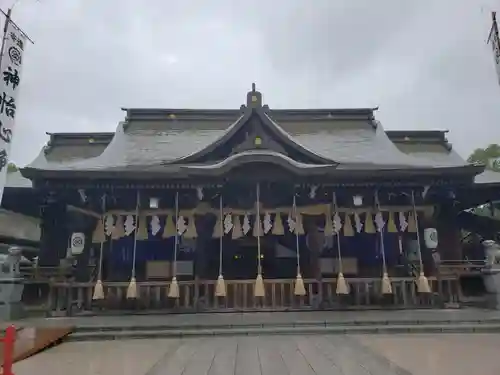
{"left": 0, "top": 247, "right": 24, "bottom": 320}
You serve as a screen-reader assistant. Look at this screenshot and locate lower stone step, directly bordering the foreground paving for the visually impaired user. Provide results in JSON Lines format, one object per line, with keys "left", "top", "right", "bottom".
{"left": 67, "top": 323, "right": 500, "bottom": 341}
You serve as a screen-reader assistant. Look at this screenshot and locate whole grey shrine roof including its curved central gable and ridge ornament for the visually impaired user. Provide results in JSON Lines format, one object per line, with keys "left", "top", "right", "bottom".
{"left": 23, "top": 90, "right": 480, "bottom": 183}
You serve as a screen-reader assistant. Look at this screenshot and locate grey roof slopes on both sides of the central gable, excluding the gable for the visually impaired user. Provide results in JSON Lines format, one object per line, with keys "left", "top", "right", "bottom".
{"left": 24, "top": 109, "right": 467, "bottom": 175}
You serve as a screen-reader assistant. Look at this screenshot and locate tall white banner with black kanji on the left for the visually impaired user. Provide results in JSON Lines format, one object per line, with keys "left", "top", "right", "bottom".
{"left": 0, "top": 18, "right": 26, "bottom": 202}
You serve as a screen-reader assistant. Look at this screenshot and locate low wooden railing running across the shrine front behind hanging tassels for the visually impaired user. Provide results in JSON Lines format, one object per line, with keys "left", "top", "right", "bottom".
{"left": 48, "top": 277, "right": 460, "bottom": 315}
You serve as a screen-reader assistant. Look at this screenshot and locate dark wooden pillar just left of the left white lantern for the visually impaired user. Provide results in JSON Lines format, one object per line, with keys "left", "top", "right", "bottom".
{"left": 38, "top": 193, "right": 68, "bottom": 267}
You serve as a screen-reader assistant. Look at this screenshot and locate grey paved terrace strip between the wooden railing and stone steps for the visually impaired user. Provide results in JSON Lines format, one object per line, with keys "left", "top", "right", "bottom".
{"left": 9, "top": 308, "right": 500, "bottom": 327}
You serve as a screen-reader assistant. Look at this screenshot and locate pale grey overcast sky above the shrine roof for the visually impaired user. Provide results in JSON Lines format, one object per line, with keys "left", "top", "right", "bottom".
{"left": 5, "top": 0, "right": 500, "bottom": 165}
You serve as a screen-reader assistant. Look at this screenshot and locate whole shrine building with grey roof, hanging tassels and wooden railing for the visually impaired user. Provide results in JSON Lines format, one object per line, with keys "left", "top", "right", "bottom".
{"left": 22, "top": 86, "right": 500, "bottom": 314}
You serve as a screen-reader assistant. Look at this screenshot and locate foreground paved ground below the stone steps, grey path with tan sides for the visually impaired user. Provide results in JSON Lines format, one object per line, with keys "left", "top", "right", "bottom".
{"left": 10, "top": 334, "right": 500, "bottom": 375}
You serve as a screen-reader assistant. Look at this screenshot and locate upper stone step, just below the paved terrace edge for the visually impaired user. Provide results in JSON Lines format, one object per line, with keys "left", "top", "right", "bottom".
{"left": 71, "top": 319, "right": 500, "bottom": 333}
